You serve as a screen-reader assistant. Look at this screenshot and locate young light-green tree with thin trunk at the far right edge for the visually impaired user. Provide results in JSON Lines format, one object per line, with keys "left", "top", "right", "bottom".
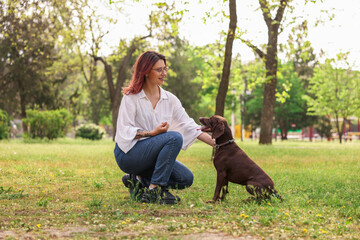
{"left": 306, "top": 54, "right": 360, "bottom": 143}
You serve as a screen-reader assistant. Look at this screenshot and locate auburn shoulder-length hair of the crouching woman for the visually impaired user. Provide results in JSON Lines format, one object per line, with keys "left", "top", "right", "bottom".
{"left": 122, "top": 51, "right": 166, "bottom": 95}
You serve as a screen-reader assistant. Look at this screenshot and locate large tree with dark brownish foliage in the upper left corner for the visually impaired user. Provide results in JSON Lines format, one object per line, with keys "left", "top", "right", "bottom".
{"left": 0, "top": 0, "right": 80, "bottom": 127}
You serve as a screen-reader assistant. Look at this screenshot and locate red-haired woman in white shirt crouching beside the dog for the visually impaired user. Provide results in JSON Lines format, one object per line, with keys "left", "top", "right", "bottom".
{"left": 114, "top": 51, "right": 215, "bottom": 204}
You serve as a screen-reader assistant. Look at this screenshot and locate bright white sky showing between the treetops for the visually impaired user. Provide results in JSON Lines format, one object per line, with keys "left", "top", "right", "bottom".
{"left": 95, "top": 0, "right": 360, "bottom": 70}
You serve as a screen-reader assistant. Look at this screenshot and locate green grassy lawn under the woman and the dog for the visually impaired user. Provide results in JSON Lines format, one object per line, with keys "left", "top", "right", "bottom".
{"left": 0, "top": 139, "right": 360, "bottom": 239}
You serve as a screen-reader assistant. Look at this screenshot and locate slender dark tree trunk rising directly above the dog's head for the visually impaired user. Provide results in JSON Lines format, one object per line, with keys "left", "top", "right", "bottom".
{"left": 215, "top": 0, "right": 237, "bottom": 116}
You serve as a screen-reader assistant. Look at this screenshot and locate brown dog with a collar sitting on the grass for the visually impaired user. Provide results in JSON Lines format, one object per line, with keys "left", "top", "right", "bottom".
{"left": 199, "top": 115, "right": 281, "bottom": 202}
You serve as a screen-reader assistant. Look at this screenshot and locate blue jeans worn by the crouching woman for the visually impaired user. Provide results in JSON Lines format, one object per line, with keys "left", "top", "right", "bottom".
{"left": 114, "top": 132, "right": 194, "bottom": 189}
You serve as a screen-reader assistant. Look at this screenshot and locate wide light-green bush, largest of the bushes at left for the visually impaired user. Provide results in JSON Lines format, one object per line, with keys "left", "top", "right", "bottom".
{"left": 23, "top": 109, "right": 72, "bottom": 140}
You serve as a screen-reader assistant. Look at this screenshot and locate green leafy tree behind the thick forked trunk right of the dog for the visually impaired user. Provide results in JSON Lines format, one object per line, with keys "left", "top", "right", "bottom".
{"left": 245, "top": 62, "right": 307, "bottom": 140}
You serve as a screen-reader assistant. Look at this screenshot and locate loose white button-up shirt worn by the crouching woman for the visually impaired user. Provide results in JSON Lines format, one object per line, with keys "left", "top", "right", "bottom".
{"left": 115, "top": 87, "right": 202, "bottom": 153}
